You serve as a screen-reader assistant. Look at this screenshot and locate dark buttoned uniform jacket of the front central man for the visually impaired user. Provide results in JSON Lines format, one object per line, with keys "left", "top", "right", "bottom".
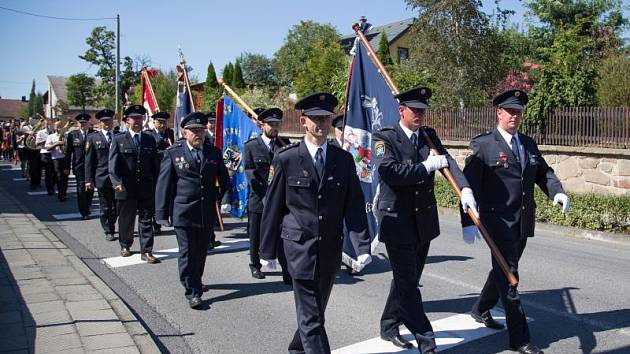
{"left": 260, "top": 142, "right": 370, "bottom": 279}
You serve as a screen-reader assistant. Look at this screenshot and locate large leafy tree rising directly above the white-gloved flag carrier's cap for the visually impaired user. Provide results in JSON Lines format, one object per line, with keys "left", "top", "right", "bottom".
{"left": 407, "top": 0, "right": 509, "bottom": 107}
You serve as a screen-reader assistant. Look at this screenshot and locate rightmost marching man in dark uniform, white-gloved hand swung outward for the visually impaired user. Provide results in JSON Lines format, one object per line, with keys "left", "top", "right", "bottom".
{"left": 462, "top": 90, "right": 569, "bottom": 354}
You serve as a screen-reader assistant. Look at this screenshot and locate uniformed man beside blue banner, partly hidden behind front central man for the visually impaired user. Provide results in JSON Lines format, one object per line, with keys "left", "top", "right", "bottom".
{"left": 243, "top": 108, "right": 289, "bottom": 280}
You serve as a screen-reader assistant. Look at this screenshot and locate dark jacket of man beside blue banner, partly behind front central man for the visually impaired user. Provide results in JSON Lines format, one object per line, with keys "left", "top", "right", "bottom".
{"left": 243, "top": 136, "right": 290, "bottom": 213}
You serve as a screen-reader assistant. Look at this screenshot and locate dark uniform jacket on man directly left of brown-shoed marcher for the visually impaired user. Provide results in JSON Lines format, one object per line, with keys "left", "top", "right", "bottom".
{"left": 85, "top": 130, "right": 115, "bottom": 188}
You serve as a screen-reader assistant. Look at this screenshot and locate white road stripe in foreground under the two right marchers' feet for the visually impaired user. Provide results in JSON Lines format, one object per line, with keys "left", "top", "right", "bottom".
{"left": 333, "top": 310, "right": 516, "bottom": 354}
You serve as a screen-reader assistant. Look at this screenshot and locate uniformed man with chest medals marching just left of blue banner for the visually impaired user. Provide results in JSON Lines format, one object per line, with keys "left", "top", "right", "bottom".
{"left": 155, "top": 112, "right": 230, "bottom": 308}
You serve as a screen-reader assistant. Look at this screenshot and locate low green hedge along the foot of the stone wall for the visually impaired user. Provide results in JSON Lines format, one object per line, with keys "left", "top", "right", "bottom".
{"left": 435, "top": 177, "right": 630, "bottom": 234}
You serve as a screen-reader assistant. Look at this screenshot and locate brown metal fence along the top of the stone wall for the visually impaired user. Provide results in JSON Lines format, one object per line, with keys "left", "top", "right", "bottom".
{"left": 281, "top": 107, "right": 630, "bottom": 149}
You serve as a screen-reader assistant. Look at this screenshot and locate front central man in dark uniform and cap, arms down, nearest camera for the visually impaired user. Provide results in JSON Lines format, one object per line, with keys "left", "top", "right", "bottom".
{"left": 260, "top": 93, "right": 371, "bottom": 354}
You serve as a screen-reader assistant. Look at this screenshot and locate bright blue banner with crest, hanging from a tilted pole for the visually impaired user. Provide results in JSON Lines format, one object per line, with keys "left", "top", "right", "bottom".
{"left": 223, "top": 95, "right": 261, "bottom": 218}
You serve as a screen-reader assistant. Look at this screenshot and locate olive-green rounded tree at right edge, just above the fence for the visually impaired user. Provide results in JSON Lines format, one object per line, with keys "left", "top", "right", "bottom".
{"left": 596, "top": 52, "right": 630, "bottom": 107}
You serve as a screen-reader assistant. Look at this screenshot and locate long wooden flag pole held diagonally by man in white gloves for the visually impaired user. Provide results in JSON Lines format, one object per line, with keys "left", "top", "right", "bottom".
{"left": 352, "top": 23, "right": 518, "bottom": 287}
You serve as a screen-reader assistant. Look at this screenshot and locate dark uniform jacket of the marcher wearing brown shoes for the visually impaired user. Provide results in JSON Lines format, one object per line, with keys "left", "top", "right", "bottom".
{"left": 109, "top": 131, "right": 159, "bottom": 200}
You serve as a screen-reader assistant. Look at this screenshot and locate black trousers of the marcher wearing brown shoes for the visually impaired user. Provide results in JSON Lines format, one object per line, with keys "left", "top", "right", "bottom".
{"left": 116, "top": 198, "right": 155, "bottom": 253}
